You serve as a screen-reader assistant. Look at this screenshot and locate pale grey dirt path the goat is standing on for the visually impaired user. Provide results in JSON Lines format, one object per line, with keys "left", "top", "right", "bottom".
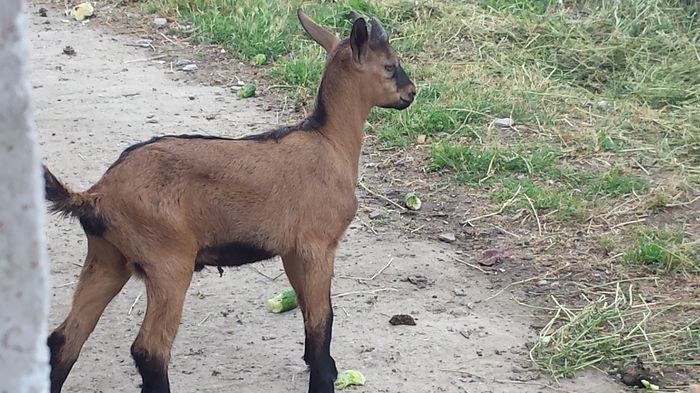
{"left": 27, "top": 2, "right": 621, "bottom": 393}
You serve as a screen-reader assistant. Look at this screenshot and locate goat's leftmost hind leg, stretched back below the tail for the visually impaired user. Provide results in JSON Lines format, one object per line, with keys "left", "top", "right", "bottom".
{"left": 47, "top": 236, "right": 131, "bottom": 393}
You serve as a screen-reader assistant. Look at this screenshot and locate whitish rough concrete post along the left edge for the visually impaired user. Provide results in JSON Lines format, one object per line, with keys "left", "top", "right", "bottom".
{"left": 0, "top": 0, "right": 49, "bottom": 393}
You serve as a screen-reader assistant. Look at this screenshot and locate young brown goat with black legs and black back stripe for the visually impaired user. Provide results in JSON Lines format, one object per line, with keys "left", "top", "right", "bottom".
{"left": 44, "top": 10, "right": 416, "bottom": 393}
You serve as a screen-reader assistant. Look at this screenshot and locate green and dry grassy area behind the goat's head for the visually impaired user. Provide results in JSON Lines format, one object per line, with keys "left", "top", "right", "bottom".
{"left": 145, "top": 0, "right": 700, "bottom": 222}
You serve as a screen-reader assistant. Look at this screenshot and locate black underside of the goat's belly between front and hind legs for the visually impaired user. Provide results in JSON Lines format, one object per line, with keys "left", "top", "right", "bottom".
{"left": 195, "top": 242, "right": 275, "bottom": 266}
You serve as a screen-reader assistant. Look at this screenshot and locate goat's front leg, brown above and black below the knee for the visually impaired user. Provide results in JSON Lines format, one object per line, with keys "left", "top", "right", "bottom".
{"left": 283, "top": 253, "right": 338, "bottom": 393}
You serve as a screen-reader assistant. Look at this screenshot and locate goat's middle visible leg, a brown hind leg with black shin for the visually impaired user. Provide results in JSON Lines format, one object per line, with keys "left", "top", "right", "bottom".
{"left": 131, "top": 257, "right": 194, "bottom": 393}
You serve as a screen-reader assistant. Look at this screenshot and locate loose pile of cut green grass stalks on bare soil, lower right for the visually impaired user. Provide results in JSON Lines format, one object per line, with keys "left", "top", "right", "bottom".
{"left": 530, "top": 282, "right": 700, "bottom": 382}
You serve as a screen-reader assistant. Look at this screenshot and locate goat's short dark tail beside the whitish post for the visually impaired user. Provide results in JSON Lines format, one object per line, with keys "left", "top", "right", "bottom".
{"left": 43, "top": 165, "right": 95, "bottom": 218}
